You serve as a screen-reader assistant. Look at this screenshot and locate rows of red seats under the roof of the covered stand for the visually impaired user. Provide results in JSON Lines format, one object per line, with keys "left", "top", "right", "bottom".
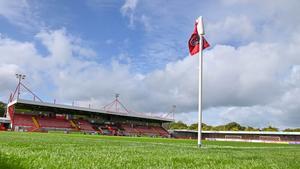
{"left": 14, "top": 111, "right": 169, "bottom": 137}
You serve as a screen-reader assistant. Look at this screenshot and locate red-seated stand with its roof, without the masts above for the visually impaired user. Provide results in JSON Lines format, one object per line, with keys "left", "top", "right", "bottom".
{"left": 9, "top": 100, "right": 171, "bottom": 137}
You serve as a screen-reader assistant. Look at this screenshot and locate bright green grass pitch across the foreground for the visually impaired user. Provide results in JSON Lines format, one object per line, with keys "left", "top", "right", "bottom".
{"left": 0, "top": 132, "right": 300, "bottom": 169}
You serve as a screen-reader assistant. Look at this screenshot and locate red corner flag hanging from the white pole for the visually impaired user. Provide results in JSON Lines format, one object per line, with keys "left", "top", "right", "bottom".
{"left": 189, "top": 22, "right": 209, "bottom": 56}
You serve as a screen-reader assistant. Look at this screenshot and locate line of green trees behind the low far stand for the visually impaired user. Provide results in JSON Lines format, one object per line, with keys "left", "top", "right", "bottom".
{"left": 168, "top": 121, "right": 300, "bottom": 132}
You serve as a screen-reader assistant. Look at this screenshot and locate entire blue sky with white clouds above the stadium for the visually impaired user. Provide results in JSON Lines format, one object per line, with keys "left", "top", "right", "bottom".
{"left": 0, "top": 0, "right": 300, "bottom": 128}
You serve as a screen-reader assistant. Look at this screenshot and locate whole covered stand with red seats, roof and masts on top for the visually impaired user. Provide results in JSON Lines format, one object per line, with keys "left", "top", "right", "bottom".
{"left": 0, "top": 74, "right": 174, "bottom": 137}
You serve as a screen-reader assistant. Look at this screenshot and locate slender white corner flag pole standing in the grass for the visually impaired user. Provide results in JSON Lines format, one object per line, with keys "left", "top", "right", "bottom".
{"left": 197, "top": 16, "right": 204, "bottom": 148}
